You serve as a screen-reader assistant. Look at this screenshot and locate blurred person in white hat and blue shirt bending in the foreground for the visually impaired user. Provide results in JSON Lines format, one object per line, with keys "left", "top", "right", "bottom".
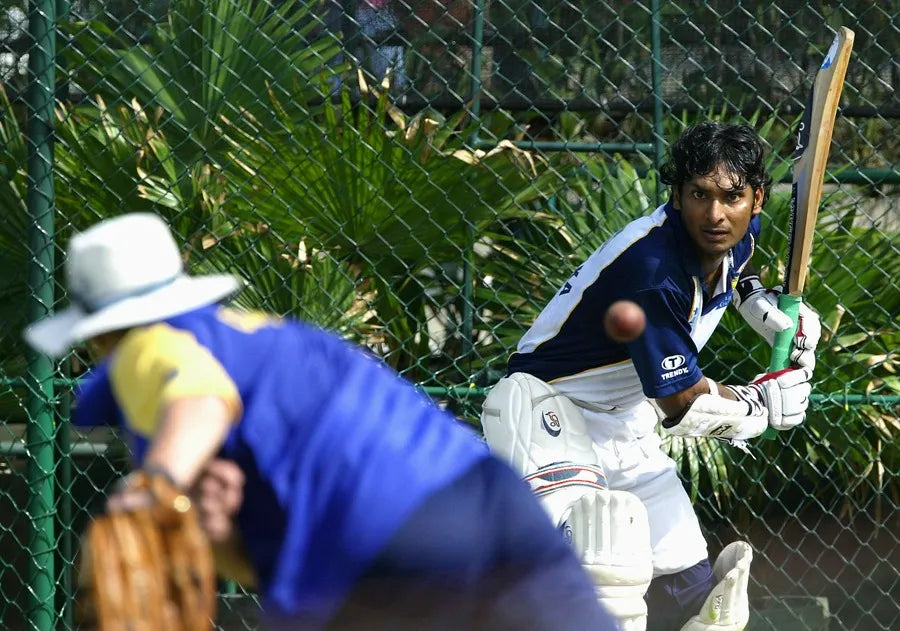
{"left": 25, "top": 213, "right": 615, "bottom": 631}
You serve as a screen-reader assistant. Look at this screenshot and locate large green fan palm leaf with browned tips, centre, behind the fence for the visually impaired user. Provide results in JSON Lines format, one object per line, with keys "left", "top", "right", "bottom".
{"left": 222, "top": 78, "right": 559, "bottom": 376}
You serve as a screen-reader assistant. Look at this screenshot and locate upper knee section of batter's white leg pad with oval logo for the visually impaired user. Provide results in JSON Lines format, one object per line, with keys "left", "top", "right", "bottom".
{"left": 481, "top": 373, "right": 606, "bottom": 524}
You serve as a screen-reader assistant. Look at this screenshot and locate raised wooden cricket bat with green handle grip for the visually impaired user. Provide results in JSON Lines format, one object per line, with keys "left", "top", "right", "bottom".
{"left": 766, "top": 27, "right": 853, "bottom": 435}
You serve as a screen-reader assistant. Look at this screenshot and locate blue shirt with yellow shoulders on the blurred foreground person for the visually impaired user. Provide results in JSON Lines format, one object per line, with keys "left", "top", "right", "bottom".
{"left": 76, "top": 306, "right": 488, "bottom": 617}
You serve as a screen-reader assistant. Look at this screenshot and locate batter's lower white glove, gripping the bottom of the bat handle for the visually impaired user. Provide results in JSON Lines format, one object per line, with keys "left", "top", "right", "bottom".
{"left": 726, "top": 367, "right": 812, "bottom": 430}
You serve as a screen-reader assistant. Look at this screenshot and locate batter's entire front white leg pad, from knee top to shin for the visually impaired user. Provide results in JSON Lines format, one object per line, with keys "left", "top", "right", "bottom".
{"left": 481, "top": 373, "right": 653, "bottom": 631}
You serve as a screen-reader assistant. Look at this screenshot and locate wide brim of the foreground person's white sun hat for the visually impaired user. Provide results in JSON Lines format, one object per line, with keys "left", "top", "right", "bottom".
{"left": 23, "top": 274, "right": 243, "bottom": 357}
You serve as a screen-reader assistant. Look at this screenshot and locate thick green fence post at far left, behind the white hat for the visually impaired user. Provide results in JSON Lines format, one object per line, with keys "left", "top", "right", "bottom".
{"left": 26, "top": 0, "right": 56, "bottom": 631}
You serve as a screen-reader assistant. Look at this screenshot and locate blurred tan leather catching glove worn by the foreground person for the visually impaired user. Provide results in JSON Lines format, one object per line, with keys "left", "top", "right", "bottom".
{"left": 83, "top": 467, "right": 216, "bottom": 631}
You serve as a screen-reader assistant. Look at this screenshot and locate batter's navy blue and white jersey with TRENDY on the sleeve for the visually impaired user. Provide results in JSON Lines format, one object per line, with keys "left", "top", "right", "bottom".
{"left": 508, "top": 203, "right": 760, "bottom": 410}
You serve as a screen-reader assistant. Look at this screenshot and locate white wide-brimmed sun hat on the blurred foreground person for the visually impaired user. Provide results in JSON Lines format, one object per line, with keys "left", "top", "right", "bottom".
{"left": 24, "top": 213, "right": 243, "bottom": 357}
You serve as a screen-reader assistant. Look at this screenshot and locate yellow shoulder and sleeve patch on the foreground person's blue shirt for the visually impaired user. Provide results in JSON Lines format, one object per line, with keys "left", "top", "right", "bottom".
{"left": 109, "top": 324, "right": 243, "bottom": 437}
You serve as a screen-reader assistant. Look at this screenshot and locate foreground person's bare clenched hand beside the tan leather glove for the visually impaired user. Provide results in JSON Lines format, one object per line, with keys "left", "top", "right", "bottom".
{"left": 190, "top": 459, "right": 245, "bottom": 543}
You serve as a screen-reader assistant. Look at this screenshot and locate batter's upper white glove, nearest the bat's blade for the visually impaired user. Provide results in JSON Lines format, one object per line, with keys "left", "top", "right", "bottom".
{"left": 734, "top": 276, "right": 822, "bottom": 370}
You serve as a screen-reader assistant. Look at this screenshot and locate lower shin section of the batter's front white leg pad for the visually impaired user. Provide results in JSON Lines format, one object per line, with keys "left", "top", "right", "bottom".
{"left": 563, "top": 491, "right": 653, "bottom": 631}
